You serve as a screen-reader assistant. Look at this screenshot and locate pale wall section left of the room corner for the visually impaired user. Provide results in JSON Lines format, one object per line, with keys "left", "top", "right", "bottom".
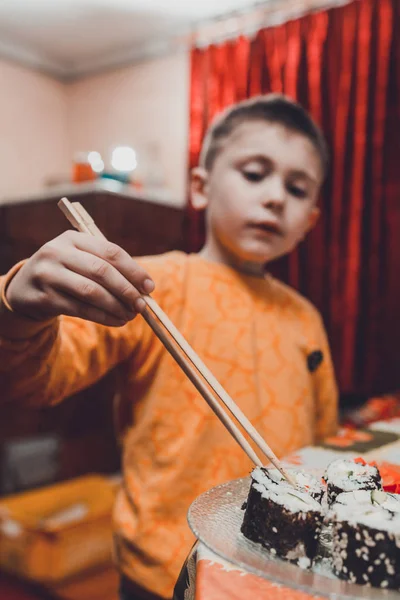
{"left": 0, "top": 61, "right": 70, "bottom": 202}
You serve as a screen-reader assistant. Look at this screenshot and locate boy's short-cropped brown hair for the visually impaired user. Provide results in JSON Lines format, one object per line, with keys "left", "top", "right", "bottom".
{"left": 200, "top": 94, "right": 329, "bottom": 174}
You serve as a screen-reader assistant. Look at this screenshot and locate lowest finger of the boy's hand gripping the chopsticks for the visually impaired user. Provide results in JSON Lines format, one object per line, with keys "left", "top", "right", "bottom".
{"left": 47, "top": 267, "right": 136, "bottom": 322}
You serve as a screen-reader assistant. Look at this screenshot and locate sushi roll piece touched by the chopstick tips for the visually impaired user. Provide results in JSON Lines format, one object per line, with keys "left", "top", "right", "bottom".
{"left": 241, "top": 467, "right": 323, "bottom": 567}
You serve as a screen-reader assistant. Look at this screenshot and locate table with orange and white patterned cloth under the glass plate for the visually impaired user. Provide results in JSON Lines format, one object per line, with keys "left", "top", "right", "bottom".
{"left": 174, "top": 418, "right": 400, "bottom": 600}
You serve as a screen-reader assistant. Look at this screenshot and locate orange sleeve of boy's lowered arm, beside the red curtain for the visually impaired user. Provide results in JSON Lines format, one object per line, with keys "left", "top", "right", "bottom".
{"left": 312, "top": 313, "right": 338, "bottom": 442}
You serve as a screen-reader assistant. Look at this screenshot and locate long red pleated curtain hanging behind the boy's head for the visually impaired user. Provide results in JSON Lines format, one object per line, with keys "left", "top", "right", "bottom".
{"left": 189, "top": 0, "right": 400, "bottom": 394}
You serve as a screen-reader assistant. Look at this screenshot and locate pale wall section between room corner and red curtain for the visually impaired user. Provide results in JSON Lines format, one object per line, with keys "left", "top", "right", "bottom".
{"left": 67, "top": 53, "right": 189, "bottom": 205}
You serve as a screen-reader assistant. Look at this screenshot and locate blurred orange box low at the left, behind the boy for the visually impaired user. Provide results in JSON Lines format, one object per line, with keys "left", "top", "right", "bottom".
{"left": 0, "top": 475, "right": 116, "bottom": 583}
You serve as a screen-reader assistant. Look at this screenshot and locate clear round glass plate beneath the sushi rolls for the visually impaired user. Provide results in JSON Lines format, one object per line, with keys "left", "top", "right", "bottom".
{"left": 188, "top": 477, "right": 400, "bottom": 600}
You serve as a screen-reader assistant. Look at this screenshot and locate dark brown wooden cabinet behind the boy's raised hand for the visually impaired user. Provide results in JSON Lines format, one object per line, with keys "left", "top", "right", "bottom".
{"left": 0, "top": 186, "right": 185, "bottom": 489}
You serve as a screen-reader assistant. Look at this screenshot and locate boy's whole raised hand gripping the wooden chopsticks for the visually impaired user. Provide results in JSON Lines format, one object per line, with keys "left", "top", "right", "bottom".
{"left": 7, "top": 231, "right": 154, "bottom": 327}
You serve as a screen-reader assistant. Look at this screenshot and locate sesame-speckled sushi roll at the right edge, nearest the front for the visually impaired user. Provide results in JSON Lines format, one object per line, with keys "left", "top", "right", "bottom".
{"left": 328, "top": 490, "right": 400, "bottom": 590}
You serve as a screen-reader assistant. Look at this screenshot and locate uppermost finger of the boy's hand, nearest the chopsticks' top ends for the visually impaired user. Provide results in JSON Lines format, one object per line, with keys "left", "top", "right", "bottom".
{"left": 65, "top": 232, "right": 154, "bottom": 294}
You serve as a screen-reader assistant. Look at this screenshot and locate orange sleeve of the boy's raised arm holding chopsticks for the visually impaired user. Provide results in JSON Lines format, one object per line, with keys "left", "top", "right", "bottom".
{"left": 0, "top": 251, "right": 184, "bottom": 406}
